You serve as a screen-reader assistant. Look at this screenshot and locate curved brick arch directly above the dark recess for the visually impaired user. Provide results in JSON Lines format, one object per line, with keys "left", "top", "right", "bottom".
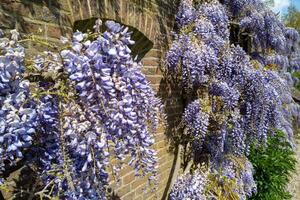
{"left": 67, "top": 0, "right": 159, "bottom": 41}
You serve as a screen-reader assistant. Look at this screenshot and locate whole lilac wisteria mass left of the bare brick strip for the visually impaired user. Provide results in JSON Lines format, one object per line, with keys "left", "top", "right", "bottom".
{"left": 0, "top": 20, "right": 162, "bottom": 199}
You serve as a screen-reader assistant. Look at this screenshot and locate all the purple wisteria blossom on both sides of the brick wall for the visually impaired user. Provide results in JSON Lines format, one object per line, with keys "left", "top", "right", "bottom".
{"left": 0, "top": 0, "right": 300, "bottom": 200}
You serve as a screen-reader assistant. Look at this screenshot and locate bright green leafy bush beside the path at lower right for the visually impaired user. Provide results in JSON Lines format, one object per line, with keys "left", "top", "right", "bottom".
{"left": 249, "top": 131, "right": 296, "bottom": 200}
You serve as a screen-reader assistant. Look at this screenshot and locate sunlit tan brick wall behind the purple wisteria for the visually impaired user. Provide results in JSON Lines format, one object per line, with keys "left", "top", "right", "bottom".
{"left": 0, "top": 0, "right": 183, "bottom": 200}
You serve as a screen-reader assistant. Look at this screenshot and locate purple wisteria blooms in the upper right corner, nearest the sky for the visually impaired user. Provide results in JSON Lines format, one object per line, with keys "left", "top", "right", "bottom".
{"left": 225, "top": 0, "right": 299, "bottom": 74}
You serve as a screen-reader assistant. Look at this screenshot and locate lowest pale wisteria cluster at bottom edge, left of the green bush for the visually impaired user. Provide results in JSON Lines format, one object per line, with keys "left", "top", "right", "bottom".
{"left": 170, "top": 158, "right": 257, "bottom": 200}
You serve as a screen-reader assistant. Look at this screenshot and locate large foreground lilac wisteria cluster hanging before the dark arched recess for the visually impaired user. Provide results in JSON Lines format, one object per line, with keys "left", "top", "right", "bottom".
{"left": 19, "top": 21, "right": 162, "bottom": 199}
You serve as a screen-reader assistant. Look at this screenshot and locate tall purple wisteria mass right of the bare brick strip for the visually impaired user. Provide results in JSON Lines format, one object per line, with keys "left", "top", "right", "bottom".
{"left": 166, "top": 0, "right": 300, "bottom": 199}
